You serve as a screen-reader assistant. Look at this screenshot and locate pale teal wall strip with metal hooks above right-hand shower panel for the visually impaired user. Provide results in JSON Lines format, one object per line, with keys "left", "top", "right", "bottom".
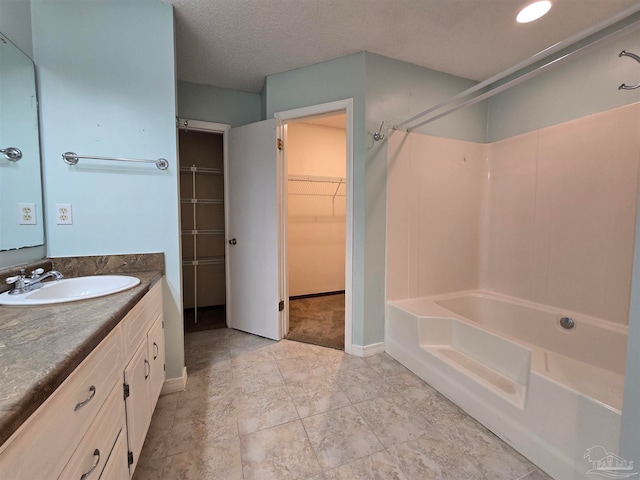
{"left": 487, "top": 28, "right": 640, "bottom": 142}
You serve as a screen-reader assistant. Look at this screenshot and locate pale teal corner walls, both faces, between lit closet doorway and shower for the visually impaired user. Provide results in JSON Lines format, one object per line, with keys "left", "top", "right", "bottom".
{"left": 265, "top": 52, "right": 486, "bottom": 346}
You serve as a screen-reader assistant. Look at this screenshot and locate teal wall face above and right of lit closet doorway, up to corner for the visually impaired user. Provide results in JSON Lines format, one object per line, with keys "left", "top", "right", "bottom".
{"left": 265, "top": 53, "right": 366, "bottom": 345}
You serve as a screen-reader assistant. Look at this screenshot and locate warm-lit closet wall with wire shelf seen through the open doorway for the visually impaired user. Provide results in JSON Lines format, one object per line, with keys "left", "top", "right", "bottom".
{"left": 286, "top": 123, "right": 347, "bottom": 296}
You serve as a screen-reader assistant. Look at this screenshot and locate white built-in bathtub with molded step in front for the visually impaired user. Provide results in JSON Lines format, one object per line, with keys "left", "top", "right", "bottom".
{"left": 385, "top": 291, "right": 627, "bottom": 480}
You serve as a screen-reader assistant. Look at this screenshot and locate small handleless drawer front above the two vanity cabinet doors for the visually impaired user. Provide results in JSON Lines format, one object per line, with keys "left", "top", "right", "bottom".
{"left": 122, "top": 282, "right": 162, "bottom": 359}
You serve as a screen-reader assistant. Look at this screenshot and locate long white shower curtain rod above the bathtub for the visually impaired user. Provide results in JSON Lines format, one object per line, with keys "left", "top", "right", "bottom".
{"left": 406, "top": 16, "right": 640, "bottom": 132}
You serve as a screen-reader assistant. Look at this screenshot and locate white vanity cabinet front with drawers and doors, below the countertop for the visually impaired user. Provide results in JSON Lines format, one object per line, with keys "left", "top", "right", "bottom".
{"left": 0, "top": 282, "right": 165, "bottom": 480}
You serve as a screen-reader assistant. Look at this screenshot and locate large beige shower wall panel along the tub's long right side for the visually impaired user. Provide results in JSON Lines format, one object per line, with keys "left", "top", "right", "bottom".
{"left": 483, "top": 105, "right": 640, "bottom": 324}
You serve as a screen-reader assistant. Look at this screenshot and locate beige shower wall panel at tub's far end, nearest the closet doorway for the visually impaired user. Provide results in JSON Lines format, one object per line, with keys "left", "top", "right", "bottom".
{"left": 387, "top": 132, "right": 487, "bottom": 300}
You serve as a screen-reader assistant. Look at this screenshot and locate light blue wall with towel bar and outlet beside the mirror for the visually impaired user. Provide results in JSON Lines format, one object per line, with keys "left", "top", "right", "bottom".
{"left": 31, "top": 0, "right": 184, "bottom": 378}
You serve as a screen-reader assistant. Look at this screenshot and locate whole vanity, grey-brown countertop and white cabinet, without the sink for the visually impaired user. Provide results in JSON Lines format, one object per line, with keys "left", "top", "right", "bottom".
{"left": 0, "top": 272, "right": 165, "bottom": 480}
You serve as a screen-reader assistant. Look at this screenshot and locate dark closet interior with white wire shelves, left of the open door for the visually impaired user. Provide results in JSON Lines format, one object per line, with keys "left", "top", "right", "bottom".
{"left": 178, "top": 128, "right": 226, "bottom": 332}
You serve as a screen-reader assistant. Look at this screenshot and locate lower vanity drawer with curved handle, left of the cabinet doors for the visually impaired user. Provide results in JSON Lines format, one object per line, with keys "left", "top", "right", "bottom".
{"left": 60, "top": 382, "right": 127, "bottom": 480}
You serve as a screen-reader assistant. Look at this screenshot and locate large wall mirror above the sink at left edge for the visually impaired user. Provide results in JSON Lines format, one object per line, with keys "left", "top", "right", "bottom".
{"left": 0, "top": 33, "right": 44, "bottom": 251}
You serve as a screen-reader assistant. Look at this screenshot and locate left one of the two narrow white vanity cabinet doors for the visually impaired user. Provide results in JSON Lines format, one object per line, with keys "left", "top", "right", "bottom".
{"left": 124, "top": 341, "right": 151, "bottom": 474}
